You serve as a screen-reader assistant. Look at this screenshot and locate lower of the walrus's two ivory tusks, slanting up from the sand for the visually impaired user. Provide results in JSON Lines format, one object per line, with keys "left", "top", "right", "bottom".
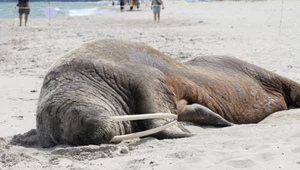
{"left": 110, "top": 120, "right": 177, "bottom": 142}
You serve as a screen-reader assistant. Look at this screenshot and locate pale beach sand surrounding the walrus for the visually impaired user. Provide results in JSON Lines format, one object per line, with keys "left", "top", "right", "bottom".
{"left": 0, "top": 0, "right": 300, "bottom": 170}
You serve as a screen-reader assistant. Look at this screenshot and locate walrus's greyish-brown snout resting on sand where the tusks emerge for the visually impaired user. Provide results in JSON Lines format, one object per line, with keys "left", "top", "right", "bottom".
{"left": 63, "top": 105, "right": 115, "bottom": 145}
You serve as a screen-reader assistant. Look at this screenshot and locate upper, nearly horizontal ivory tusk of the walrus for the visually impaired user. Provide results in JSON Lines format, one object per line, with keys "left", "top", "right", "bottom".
{"left": 112, "top": 113, "right": 177, "bottom": 122}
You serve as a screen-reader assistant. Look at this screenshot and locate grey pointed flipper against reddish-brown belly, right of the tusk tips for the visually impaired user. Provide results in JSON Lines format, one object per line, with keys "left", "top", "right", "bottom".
{"left": 178, "top": 104, "right": 234, "bottom": 127}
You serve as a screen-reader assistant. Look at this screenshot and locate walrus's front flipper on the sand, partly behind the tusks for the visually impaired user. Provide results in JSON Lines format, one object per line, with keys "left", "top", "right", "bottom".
{"left": 143, "top": 119, "right": 194, "bottom": 139}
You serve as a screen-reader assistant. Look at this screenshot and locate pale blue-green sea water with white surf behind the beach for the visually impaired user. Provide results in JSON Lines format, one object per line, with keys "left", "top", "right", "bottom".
{"left": 0, "top": 0, "right": 113, "bottom": 18}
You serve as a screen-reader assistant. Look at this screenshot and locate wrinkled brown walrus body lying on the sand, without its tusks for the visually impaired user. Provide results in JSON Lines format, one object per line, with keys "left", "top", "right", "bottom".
{"left": 37, "top": 40, "right": 300, "bottom": 147}
